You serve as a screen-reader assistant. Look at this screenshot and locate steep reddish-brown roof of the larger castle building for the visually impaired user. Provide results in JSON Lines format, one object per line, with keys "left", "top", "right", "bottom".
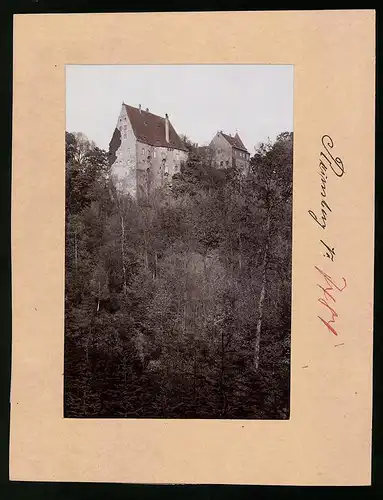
{"left": 124, "top": 104, "right": 187, "bottom": 151}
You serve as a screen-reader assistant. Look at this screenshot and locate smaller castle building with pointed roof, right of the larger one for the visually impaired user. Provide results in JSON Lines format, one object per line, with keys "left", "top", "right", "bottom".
{"left": 209, "top": 130, "right": 250, "bottom": 174}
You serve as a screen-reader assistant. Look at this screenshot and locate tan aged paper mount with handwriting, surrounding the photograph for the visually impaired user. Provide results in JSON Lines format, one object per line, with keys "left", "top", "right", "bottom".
{"left": 10, "top": 10, "right": 375, "bottom": 485}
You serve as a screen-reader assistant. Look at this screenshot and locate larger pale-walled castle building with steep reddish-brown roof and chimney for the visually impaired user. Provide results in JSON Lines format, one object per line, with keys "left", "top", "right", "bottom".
{"left": 109, "top": 103, "right": 188, "bottom": 197}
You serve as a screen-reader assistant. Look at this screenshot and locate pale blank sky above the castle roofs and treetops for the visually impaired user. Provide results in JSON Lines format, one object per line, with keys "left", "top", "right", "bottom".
{"left": 66, "top": 64, "right": 293, "bottom": 153}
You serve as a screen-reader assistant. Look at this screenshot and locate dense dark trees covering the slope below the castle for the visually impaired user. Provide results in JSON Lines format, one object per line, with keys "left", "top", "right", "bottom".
{"left": 64, "top": 132, "right": 293, "bottom": 419}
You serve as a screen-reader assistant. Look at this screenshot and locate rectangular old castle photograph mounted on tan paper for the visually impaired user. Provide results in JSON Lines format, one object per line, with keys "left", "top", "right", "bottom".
{"left": 63, "top": 64, "right": 294, "bottom": 420}
